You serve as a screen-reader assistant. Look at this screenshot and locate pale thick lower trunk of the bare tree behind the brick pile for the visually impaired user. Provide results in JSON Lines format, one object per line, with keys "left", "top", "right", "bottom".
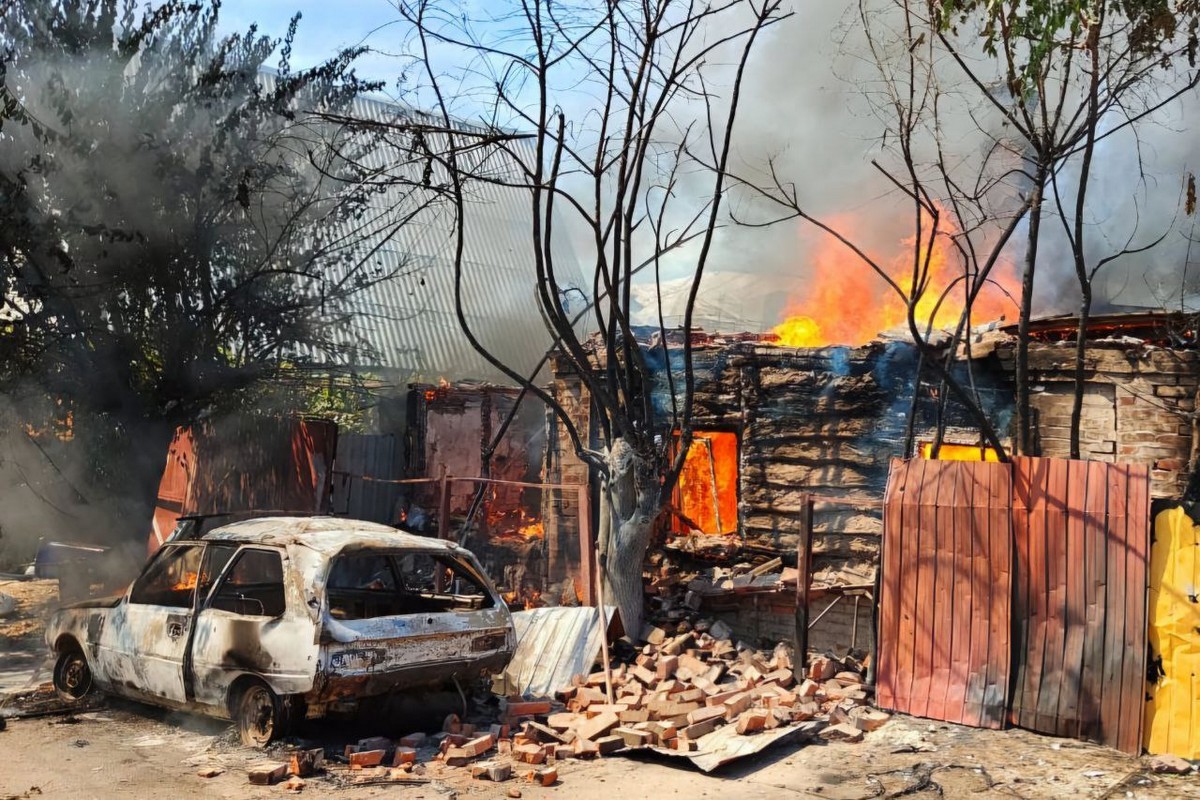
{"left": 599, "top": 439, "right": 659, "bottom": 642}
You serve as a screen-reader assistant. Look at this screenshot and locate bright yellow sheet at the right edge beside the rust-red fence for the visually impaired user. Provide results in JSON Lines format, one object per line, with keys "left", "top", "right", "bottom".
{"left": 1145, "top": 509, "right": 1200, "bottom": 759}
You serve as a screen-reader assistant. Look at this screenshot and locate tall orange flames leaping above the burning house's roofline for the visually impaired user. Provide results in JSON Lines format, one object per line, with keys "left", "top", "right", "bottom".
{"left": 773, "top": 210, "right": 1019, "bottom": 347}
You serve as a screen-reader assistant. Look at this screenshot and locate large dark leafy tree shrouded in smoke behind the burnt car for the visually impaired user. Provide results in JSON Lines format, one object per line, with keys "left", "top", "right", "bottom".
{"left": 0, "top": 0, "right": 392, "bottom": 530}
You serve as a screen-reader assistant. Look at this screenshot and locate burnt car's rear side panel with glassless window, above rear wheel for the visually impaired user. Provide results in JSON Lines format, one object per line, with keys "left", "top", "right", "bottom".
{"left": 190, "top": 546, "right": 317, "bottom": 705}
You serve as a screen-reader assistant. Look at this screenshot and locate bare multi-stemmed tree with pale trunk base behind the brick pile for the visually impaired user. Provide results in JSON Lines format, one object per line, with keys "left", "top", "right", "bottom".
{"left": 397, "top": 0, "right": 785, "bottom": 638}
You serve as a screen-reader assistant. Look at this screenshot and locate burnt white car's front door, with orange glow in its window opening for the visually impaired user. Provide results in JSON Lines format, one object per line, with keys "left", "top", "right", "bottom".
{"left": 97, "top": 543, "right": 204, "bottom": 703}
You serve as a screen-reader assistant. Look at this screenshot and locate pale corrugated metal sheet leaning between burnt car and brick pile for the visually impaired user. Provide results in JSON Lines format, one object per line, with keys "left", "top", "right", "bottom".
{"left": 497, "top": 606, "right": 617, "bottom": 698}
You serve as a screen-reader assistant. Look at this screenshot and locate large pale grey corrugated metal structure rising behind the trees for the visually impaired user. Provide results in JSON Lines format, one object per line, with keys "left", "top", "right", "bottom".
{"left": 314, "top": 90, "right": 583, "bottom": 384}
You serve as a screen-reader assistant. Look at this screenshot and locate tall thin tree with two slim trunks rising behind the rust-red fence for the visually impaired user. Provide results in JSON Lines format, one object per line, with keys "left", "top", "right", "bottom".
{"left": 936, "top": 0, "right": 1200, "bottom": 458}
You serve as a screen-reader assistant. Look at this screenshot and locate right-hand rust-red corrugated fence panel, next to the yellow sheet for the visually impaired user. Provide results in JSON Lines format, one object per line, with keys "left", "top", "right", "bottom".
{"left": 1012, "top": 458, "right": 1150, "bottom": 753}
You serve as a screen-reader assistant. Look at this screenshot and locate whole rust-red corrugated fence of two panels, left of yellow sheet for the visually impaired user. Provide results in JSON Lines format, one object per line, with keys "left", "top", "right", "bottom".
{"left": 877, "top": 458, "right": 1150, "bottom": 753}
